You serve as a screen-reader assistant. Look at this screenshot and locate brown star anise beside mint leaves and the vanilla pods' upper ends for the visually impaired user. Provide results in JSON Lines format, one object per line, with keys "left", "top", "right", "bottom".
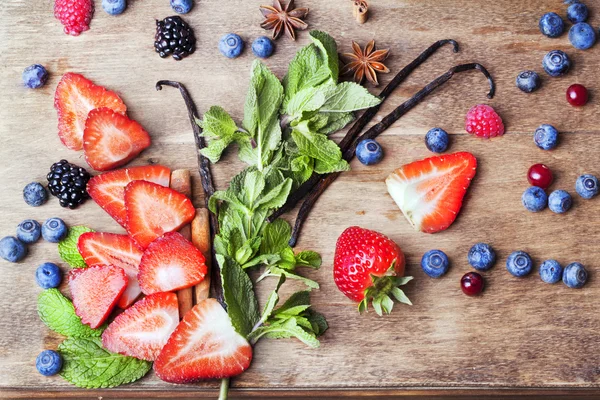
{"left": 342, "top": 40, "right": 390, "bottom": 86}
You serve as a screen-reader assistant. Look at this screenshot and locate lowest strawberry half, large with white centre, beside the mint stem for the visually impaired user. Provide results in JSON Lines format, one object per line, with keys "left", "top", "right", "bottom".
{"left": 154, "top": 299, "right": 252, "bottom": 383}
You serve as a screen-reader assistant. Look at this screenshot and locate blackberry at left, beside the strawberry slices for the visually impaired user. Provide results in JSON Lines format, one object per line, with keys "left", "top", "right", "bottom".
{"left": 46, "top": 160, "right": 90, "bottom": 209}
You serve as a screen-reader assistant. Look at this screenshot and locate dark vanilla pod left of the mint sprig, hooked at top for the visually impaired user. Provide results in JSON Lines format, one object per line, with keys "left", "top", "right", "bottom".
{"left": 156, "top": 80, "right": 223, "bottom": 304}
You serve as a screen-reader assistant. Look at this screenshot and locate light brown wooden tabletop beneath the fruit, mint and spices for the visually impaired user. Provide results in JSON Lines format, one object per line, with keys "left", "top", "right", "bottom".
{"left": 0, "top": 0, "right": 600, "bottom": 398}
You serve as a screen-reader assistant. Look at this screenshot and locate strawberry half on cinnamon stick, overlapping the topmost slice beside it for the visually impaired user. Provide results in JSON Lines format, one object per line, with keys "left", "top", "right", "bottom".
{"left": 125, "top": 181, "right": 196, "bottom": 249}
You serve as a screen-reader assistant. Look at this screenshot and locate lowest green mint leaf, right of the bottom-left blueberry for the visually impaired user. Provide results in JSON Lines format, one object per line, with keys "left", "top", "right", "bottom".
{"left": 58, "top": 338, "right": 152, "bottom": 389}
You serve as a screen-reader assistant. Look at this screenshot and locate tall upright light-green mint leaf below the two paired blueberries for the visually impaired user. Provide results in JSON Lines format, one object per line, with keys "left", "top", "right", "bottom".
{"left": 240, "top": 60, "right": 283, "bottom": 171}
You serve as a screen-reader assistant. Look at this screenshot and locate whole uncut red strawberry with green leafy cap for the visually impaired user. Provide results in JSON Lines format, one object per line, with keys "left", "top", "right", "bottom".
{"left": 333, "top": 226, "right": 412, "bottom": 315}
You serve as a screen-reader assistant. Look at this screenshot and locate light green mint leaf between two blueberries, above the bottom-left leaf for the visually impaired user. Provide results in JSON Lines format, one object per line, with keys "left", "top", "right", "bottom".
{"left": 38, "top": 289, "right": 104, "bottom": 338}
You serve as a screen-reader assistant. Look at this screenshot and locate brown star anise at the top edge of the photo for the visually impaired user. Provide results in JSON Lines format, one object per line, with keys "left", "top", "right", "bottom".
{"left": 260, "top": 0, "right": 308, "bottom": 40}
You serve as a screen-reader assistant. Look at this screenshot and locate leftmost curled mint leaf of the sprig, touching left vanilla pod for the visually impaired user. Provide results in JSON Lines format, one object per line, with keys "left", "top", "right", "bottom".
{"left": 198, "top": 106, "right": 249, "bottom": 163}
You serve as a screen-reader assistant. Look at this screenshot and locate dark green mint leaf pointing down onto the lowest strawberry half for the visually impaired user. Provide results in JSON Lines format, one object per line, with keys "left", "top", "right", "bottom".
{"left": 217, "top": 255, "right": 260, "bottom": 337}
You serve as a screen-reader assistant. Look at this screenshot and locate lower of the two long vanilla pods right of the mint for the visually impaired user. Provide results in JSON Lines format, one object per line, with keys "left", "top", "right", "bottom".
{"left": 290, "top": 63, "right": 496, "bottom": 247}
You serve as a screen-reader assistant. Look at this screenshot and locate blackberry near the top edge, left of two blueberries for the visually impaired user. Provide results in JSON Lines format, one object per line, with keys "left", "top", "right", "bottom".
{"left": 154, "top": 15, "right": 196, "bottom": 61}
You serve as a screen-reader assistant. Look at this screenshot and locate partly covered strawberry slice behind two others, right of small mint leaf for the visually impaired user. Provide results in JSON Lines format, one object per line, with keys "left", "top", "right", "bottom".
{"left": 77, "top": 232, "right": 144, "bottom": 309}
